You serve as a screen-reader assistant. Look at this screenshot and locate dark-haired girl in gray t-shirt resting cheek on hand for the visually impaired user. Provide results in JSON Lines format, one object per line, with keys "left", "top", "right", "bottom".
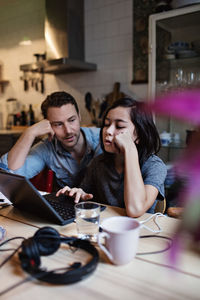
{"left": 57, "top": 98, "right": 167, "bottom": 217}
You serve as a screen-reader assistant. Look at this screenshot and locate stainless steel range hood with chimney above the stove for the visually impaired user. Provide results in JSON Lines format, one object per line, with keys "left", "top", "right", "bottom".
{"left": 20, "top": 0, "right": 97, "bottom": 74}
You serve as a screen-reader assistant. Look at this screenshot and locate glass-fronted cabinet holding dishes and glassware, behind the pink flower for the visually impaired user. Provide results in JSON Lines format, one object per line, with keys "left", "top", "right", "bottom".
{"left": 148, "top": 4, "right": 200, "bottom": 160}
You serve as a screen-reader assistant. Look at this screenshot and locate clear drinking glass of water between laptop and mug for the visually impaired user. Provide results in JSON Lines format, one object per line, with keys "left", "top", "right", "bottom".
{"left": 75, "top": 201, "right": 100, "bottom": 242}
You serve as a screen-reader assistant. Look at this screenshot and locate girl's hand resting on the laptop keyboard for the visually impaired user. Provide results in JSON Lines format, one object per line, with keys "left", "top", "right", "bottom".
{"left": 56, "top": 186, "right": 93, "bottom": 203}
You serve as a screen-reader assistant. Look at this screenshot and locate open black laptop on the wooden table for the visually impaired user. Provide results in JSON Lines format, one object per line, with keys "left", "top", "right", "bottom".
{"left": 0, "top": 170, "right": 106, "bottom": 225}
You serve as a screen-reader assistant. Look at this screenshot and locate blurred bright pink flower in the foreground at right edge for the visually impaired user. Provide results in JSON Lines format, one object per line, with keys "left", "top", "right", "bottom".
{"left": 146, "top": 89, "right": 200, "bottom": 253}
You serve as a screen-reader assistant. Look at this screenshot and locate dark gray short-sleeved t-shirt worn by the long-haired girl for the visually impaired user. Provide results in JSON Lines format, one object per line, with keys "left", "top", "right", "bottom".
{"left": 81, "top": 153, "right": 167, "bottom": 212}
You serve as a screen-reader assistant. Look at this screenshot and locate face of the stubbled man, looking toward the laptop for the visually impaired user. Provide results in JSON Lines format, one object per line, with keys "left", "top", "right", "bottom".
{"left": 47, "top": 103, "right": 80, "bottom": 150}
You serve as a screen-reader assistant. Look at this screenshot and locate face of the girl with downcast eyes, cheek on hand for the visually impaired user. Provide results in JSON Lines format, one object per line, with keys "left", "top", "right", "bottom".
{"left": 103, "top": 106, "right": 137, "bottom": 153}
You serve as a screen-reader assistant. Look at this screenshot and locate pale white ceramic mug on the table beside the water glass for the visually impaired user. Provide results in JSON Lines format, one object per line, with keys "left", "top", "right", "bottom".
{"left": 98, "top": 216, "right": 140, "bottom": 265}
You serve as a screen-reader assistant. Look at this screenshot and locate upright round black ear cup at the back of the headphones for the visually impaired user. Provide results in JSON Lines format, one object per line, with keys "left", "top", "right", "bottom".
{"left": 33, "top": 226, "right": 60, "bottom": 256}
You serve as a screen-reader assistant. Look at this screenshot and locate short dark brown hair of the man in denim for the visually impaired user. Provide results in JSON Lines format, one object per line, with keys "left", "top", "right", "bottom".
{"left": 41, "top": 92, "right": 79, "bottom": 119}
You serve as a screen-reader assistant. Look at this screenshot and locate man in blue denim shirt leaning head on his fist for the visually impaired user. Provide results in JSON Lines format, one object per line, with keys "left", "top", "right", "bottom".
{"left": 1, "top": 92, "right": 102, "bottom": 187}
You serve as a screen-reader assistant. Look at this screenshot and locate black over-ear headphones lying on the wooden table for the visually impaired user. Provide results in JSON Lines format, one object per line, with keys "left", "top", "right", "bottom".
{"left": 19, "top": 227, "right": 99, "bottom": 284}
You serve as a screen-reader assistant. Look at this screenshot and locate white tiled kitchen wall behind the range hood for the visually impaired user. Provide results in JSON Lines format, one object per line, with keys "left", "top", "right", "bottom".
{"left": 0, "top": 0, "right": 147, "bottom": 124}
